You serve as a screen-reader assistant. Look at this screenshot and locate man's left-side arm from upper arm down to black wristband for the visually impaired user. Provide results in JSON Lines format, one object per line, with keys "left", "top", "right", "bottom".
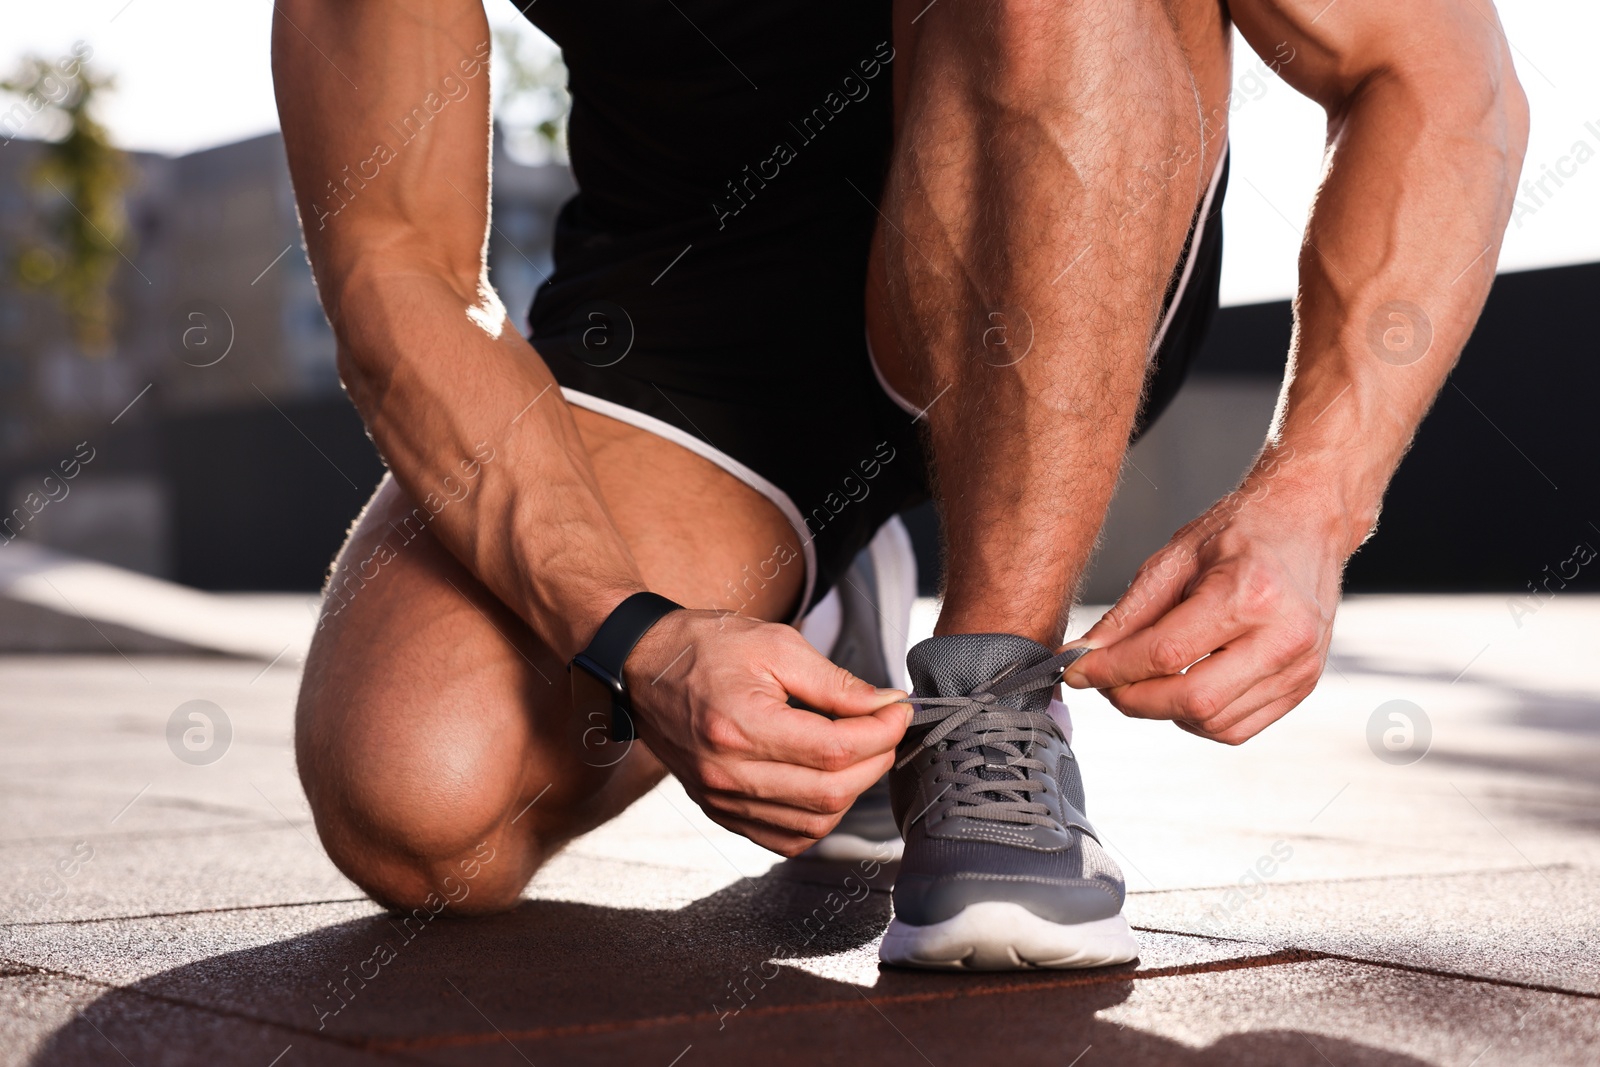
{"left": 272, "top": 0, "right": 643, "bottom": 656}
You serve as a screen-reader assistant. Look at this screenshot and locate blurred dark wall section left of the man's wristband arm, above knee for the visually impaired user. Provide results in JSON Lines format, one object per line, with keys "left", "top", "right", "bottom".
{"left": 160, "top": 397, "right": 384, "bottom": 590}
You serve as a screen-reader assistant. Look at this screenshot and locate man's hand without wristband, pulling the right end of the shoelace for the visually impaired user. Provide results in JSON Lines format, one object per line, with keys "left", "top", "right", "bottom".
{"left": 1066, "top": 456, "right": 1362, "bottom": 744}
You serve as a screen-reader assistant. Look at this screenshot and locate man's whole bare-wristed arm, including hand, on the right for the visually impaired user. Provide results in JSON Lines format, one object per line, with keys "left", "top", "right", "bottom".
{"left": 1067, "top": 0, "right": 1528, "bottom": 744}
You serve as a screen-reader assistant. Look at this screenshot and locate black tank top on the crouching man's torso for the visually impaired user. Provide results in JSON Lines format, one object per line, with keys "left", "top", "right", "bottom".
{"left": 526, "top": 0, "right": 894, "bottom": 391}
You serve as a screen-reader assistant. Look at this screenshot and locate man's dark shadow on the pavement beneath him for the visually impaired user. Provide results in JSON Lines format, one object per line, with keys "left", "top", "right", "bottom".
{"left": 32, "top": 864, "right": 1422, "bottom": 1067}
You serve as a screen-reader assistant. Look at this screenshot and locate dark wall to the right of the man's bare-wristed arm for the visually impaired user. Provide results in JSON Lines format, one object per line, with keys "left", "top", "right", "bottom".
{"left": 1347, "top": 264, "right": 1600, "bottom": 592}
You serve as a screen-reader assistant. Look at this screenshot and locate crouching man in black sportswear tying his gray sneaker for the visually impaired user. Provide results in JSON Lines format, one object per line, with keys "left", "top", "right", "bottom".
{"left": 274, "top": 0, "right": 1526, "bottom": 968}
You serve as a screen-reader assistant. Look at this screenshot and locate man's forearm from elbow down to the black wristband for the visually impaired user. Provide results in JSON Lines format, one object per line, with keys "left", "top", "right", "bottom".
{"left": 328, "top": 272, "right": 645, "bottom": 657}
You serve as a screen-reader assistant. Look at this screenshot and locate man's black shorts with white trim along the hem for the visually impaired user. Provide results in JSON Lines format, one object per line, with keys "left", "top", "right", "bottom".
{"left": 541, "top": 157, "right": 1227, "bottom": 617}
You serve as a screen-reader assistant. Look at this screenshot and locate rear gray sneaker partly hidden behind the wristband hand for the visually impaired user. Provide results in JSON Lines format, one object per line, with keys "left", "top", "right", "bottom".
{"left": 803, "top": 517, "right": 917, "bottom": 862}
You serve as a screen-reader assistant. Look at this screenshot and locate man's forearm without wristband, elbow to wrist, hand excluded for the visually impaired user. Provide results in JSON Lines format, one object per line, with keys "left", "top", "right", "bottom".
{"left": 1253, "top": 6, "right": 1526, "bottom": 555}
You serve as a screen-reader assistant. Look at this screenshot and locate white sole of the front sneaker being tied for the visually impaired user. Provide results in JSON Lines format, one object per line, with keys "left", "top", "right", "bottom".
{"left": 878, "top": 901, "right": 1139, "bottom": 971}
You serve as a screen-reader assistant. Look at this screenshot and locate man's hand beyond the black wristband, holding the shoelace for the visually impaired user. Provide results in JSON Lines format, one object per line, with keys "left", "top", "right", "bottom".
{"left": 624, "top": 611, "right": 910, "bottom": 856}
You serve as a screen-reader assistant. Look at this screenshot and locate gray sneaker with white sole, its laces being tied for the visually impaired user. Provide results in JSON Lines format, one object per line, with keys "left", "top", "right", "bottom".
{"left": 878, "top": 633, "right": 1139, "bottom": 969}
